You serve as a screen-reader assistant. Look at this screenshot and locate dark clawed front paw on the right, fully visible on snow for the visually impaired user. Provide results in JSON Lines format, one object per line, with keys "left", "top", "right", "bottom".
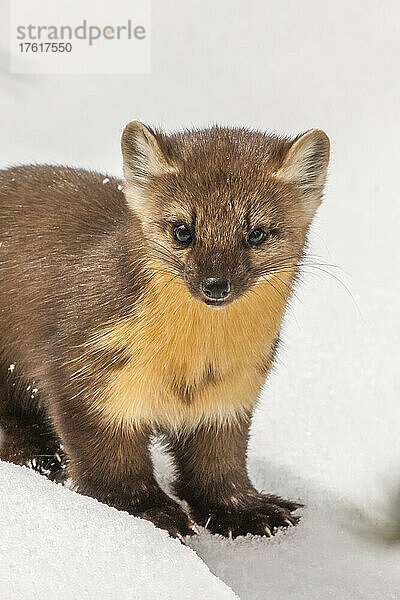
{"left": 192, "top": 494, "right": 302, "bottom": 538}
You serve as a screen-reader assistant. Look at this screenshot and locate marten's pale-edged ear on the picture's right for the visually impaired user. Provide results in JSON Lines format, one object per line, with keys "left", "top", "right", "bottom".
{"left": 276, "top": 129, "right": 330, "bottom": 218}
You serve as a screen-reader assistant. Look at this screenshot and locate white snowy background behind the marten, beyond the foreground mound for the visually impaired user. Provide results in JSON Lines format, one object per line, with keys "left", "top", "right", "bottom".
{"left": 0, "top": 0, "right": 400, "bottom": 600}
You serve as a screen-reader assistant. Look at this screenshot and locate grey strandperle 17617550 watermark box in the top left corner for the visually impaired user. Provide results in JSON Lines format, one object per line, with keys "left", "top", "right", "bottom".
{"left": 10, "top": 0, "right": 150, "bottom": 74}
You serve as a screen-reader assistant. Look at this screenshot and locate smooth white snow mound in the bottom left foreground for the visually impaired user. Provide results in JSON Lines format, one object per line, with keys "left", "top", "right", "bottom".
{"left": 0, "top": 462, "right": 237, "bottom": 600}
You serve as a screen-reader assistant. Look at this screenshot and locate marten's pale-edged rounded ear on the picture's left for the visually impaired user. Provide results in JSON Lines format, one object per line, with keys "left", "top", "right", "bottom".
{"left": 121, "top": 121, "right": 176, "bottom": 209}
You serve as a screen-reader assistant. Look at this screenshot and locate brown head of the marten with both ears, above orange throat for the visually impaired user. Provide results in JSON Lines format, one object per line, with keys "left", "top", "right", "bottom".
{"left": 122, "top": 121, "right": 329, "bottom": 307}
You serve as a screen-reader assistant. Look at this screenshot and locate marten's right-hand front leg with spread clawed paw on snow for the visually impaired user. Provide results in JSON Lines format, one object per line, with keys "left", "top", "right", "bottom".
{"left": 167, "top": 419, "right": 301, "bottom": 537}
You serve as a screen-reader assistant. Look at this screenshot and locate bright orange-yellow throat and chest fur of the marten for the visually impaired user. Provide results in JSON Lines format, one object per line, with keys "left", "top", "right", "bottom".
{"left": 86, "top": 276, "right": 289, "bottom": 430}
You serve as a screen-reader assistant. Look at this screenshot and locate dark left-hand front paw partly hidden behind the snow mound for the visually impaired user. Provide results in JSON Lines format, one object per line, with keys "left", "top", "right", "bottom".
{"left": 130, "top": 500, "right": 196, "bottom": 541}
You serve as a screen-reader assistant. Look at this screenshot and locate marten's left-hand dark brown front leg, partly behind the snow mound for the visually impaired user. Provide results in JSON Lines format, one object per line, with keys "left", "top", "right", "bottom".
{"left": 52, "top": 402, "right": 194, "bottom": 537}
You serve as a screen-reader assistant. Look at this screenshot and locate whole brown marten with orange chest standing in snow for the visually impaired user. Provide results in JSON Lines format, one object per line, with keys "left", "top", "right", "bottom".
{"left": 0, "top": 122, "right": 329, "bottom": 537}
